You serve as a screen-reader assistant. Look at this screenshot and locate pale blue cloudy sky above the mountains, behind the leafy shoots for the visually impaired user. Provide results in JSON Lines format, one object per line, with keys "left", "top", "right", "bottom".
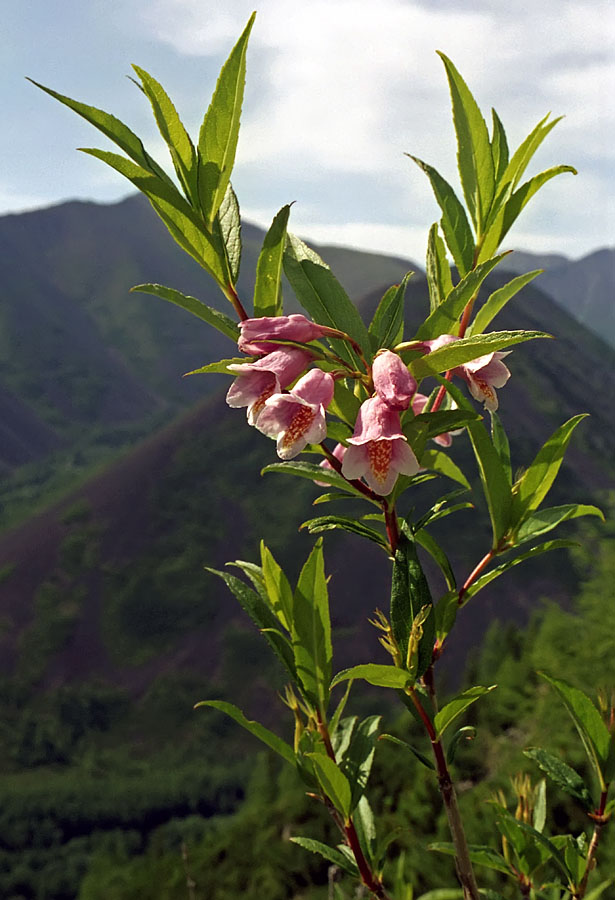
{"left": 0, "top": 0, "right": 615, "bottom": 264}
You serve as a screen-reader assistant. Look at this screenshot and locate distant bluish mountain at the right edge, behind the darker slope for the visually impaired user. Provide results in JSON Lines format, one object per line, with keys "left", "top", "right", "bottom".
{"left": 502, "top": 247, "right": 615, "bottom": 346}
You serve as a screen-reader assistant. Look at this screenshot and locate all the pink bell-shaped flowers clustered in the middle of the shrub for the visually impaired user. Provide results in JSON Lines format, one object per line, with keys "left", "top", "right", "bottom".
{"left": 226, "top": 314, "right": 510, "bottom": 497}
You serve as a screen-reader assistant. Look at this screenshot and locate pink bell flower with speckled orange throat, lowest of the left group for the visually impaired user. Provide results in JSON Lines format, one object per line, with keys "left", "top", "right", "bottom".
{"left": 256, "top": 369, "right": 335, "bottom": 459}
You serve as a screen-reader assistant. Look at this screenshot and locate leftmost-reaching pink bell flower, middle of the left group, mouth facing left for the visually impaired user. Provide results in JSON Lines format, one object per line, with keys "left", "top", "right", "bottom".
{"left": 226, "top": 347, "right": 312, "bottom": 425}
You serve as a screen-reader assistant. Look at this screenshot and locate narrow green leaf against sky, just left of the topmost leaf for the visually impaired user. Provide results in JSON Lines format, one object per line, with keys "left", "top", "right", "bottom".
{"left": 133, "top": 65, "right": 198, "bottom": 207}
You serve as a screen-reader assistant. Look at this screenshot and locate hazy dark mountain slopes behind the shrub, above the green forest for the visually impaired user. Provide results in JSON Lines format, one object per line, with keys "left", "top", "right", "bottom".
{"left": 0, "top": 190, "right": 615, "bottom": 690}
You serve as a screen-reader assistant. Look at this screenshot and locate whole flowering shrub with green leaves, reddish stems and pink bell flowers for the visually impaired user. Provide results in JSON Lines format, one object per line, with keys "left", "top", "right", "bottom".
{"left": 36, "top": 17, "right": 615, "bottom": 900}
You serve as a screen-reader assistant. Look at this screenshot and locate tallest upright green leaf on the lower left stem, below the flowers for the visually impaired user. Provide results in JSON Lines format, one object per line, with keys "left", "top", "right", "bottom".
{"left": 291, "top": 538, "right": 333, "bottom": 715}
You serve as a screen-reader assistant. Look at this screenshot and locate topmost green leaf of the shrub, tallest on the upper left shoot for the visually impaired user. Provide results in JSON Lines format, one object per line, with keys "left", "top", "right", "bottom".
{"left": 198, "top": 13, "right": 256, "bottom": 227}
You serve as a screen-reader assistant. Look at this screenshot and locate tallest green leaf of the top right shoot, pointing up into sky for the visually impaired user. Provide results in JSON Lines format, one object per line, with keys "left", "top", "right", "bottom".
{"left": 438, "top": 51, "right": 495, "bottom": 234}
